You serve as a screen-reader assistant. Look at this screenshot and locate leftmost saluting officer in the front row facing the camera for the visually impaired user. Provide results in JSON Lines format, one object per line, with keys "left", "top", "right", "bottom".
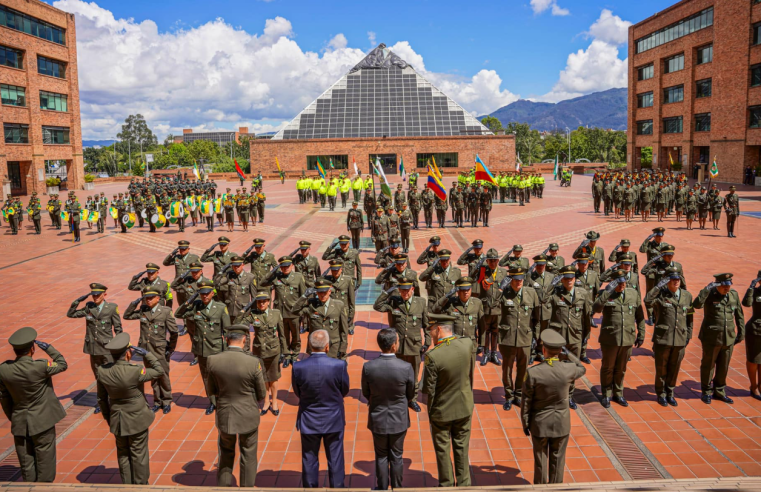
{"left": 66, "top": 283, "right": 122, "bottom": 413}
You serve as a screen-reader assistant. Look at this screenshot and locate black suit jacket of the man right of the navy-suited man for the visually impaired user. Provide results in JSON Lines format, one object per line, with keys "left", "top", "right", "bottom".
{"left": 362, "top": 355, "right": 415, "bottom": 434}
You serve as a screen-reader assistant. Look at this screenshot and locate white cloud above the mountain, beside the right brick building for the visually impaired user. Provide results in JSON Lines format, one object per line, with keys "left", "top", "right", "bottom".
{"left": 538, "top": 9, "right": 631, "bottom": 102}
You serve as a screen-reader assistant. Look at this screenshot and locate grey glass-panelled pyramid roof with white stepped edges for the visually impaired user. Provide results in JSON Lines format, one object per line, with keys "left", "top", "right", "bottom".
{"left": 273, "top": 43, "right": 492, "bottom": 140}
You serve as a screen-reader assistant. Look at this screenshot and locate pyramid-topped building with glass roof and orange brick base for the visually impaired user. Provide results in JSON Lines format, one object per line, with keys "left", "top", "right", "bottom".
{"left": 250, "top": 44, "right": 515, "bottom": 174}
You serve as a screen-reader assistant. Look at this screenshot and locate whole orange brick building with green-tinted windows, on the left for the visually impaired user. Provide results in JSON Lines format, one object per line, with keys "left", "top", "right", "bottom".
{"left": 0, "top": 0, "right": 84, "bottom": 198}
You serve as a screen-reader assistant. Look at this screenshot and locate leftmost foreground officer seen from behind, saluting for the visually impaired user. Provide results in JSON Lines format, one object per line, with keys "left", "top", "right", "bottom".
{"left": 0, "top": 327, "right": 68, "bottom": 482}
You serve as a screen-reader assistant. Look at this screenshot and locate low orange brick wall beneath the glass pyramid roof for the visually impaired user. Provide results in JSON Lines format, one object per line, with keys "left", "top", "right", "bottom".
{"left": 250, "top": 135, "right": 515, "bottom": 174}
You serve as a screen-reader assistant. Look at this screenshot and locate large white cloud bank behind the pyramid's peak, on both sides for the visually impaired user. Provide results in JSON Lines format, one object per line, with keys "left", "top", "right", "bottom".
{"left": 55, "top": 0, "right": 517, "bottom": 139}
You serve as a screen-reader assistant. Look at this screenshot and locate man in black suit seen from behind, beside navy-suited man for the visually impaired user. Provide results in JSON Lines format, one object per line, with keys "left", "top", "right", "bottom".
{"left": 362, "top": 328, "right": 415, "bottom": 490}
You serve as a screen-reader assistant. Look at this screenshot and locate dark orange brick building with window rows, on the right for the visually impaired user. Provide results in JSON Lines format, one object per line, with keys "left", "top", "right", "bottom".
{"left": 627, "top": 0, "right": 761, "bottom": 182}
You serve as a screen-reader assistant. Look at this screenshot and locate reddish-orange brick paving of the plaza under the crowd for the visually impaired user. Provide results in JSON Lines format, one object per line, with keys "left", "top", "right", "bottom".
{"left": 0, "top": 176, "right": 761, "bottom": 488}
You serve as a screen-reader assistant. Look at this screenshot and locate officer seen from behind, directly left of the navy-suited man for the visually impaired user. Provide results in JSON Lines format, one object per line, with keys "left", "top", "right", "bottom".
{"left": 208, "top": 324, "right": 267, "bottom": 487}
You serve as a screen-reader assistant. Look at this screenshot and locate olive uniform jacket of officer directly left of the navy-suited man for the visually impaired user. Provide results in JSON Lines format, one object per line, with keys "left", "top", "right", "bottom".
{"left": 207, "top": 347, "right": 267, "bottom": 434}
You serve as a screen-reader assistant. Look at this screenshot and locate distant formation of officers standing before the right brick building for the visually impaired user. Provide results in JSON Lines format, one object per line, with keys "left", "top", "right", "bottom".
{"left": 592, "top": 171, "right": 740, "bottom": 237}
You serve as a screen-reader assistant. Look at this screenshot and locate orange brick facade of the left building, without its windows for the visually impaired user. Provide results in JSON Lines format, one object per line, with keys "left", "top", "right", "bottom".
{"left": 0, "top": 0, "right": 84, "bottom": 199}
